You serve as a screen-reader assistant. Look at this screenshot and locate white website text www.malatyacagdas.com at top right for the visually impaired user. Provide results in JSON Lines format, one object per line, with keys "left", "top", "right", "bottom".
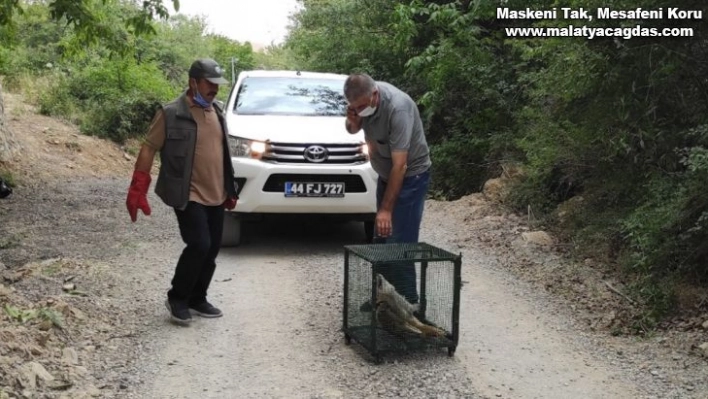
{"left": 504, "top": 25, "right": 694, "bottom": 39}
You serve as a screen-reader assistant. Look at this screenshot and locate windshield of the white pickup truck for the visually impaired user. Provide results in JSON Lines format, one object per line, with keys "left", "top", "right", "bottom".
{"left": 234, "top": 77, "right": 347, "bottom": 116}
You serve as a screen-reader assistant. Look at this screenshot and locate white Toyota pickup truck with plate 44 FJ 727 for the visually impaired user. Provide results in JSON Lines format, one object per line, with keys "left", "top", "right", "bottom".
{"left": 222, "top": 71, "right": 377, "bottom": 246}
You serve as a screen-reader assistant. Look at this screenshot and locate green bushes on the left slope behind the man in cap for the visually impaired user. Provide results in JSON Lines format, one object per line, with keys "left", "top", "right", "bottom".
{"left": 0, "top": 0, "right": 255, "bottom": 142}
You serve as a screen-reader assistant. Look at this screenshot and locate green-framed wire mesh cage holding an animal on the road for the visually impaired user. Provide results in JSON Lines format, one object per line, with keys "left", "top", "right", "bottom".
{"left": 343, "top": 243, "right": 462, "bottom": 362}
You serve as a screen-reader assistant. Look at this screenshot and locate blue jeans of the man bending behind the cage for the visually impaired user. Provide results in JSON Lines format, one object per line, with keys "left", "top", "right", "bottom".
{"left": 374, "top": 171, "right": 430, "bottom": 303}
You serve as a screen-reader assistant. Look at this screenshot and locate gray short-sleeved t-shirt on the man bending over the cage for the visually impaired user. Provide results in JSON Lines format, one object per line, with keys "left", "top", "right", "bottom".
{"left": 361, "top": 82, "right": 431, "bottom": 180}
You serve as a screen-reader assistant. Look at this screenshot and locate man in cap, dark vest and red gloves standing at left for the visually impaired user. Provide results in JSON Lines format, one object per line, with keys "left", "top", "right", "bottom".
{"left": 126, "top": 59, "right": 237, "bottom": 325}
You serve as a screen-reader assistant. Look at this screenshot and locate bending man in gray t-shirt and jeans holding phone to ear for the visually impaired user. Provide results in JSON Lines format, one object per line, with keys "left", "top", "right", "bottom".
{"left": 344, "top": 74, "right": 431, "bottom": 303}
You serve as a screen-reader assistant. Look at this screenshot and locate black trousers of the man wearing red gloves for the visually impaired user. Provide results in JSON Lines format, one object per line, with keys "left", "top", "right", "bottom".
{"left": 167, "top": 202, "right": 224, "bottom": 305}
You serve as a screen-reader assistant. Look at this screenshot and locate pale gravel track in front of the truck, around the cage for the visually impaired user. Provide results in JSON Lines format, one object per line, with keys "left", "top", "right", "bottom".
{"left": 121, "top": 200, "right": 639, "bottom": 398}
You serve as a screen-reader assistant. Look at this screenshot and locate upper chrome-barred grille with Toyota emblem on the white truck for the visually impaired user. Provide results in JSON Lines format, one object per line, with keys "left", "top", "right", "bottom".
{"left": 261, "top": 143, "right": 368, "bottom": 165}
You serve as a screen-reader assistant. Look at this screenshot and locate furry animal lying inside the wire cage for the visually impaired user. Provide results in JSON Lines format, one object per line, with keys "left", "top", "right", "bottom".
{"left": 375, "top": 274, "right": 448, "bottom": 337}
